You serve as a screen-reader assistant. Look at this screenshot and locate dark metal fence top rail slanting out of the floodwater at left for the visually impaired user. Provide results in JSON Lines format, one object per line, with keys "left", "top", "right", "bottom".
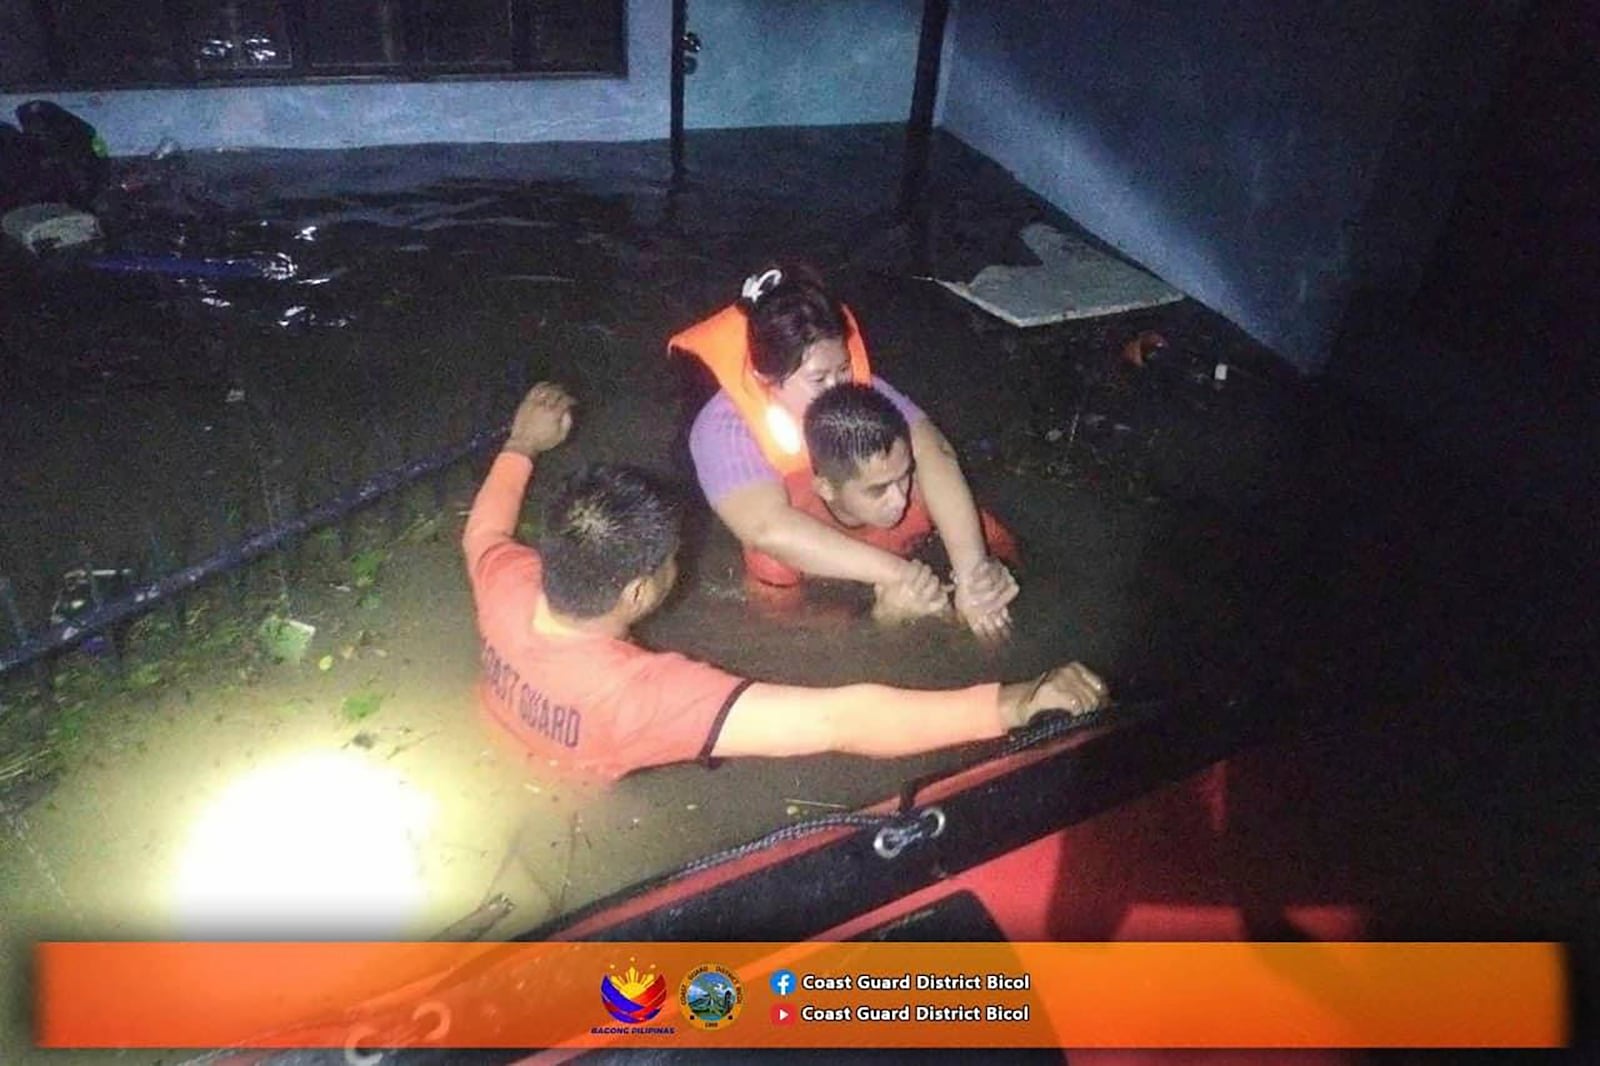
{"left": 0, "top": 424, "right": 510, "bottom": 675}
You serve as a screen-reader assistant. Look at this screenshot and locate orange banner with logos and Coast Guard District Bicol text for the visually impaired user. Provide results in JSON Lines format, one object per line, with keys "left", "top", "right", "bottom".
{"left": 37, "top": 941, "right": 1568, "bottom": 1050}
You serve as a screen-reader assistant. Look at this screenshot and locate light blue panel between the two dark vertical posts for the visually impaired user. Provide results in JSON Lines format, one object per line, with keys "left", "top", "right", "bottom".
{"left": 683, "top": 0, "right": 922, "bottom": 130}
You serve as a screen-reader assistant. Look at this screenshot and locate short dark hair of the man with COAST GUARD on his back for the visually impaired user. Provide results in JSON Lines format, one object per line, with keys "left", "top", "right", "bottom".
{"left": 538, "top": 464, "right": 682, "bottom": 618}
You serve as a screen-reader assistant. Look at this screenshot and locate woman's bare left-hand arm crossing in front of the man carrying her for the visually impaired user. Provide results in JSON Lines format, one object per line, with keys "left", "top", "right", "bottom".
{"left": 712, "top": 482, "right": 906, "bottom": 584}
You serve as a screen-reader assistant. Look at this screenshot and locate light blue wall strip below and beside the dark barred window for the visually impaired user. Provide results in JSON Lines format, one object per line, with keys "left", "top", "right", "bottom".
{"left": 0, "top": 0, "right": 672, "bottom": 155}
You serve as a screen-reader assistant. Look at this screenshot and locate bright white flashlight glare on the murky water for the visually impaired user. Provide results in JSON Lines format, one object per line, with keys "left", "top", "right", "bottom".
{"left": 176, "top": 752, "right": 434, "bottom": 940}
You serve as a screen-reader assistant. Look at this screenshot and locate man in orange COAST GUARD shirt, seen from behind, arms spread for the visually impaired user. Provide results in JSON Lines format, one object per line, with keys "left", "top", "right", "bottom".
{"left": 461, "top": 377, "right": 1107, "bottom": 779}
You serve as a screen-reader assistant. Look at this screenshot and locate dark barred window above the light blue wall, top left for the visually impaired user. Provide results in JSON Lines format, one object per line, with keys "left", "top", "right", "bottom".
{"left": 0, "top": 0, "right": 627, "bottom": 91}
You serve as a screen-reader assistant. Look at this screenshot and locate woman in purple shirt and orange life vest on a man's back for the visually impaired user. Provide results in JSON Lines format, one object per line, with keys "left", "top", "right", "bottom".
{"left": 669, "top": 267, "right": 1018, "bottom": 639}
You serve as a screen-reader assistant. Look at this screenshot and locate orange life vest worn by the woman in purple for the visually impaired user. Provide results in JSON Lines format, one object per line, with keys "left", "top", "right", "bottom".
{"left": 667, "top": 296, "right": 872, "bottom": 475}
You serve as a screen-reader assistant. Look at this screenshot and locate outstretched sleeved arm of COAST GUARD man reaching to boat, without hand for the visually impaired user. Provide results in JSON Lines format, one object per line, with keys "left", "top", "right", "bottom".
{"left": 712, "top": 682, "right": 1037, "bottom": 759}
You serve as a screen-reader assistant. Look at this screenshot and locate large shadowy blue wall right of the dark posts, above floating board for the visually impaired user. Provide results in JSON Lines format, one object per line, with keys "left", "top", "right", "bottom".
{"left": 941, "top": 0, "right": 1522, "bottom": 371}
